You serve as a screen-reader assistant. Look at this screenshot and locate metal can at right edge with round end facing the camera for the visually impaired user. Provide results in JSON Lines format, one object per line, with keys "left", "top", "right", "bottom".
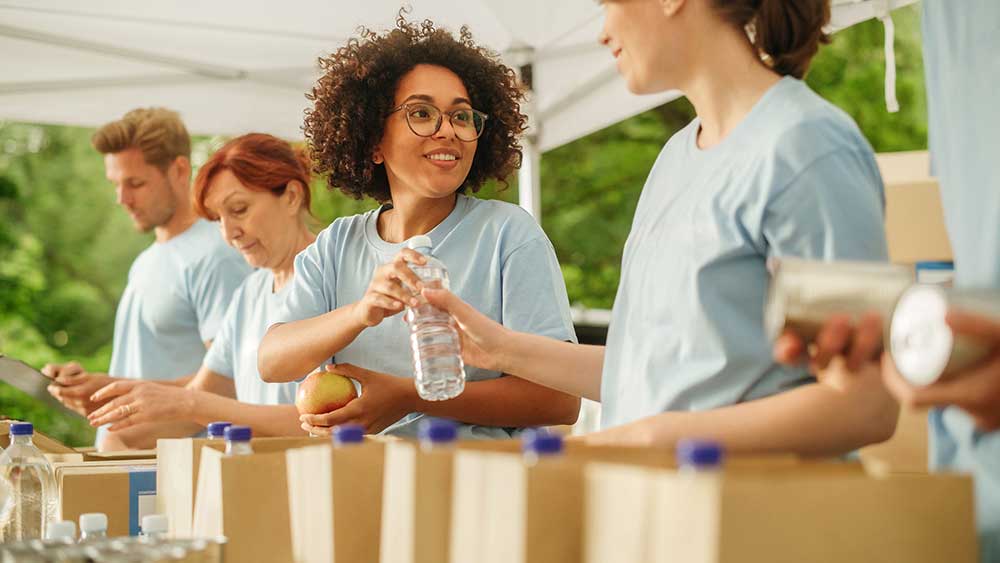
{"left": 889, "top": 285, "right": 1000, "bottom": 386}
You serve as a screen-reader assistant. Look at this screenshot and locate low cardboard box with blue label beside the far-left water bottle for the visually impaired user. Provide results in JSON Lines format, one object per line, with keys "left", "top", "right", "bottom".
{"left": 53, "top": 460, "right": 156, "bottom": 536}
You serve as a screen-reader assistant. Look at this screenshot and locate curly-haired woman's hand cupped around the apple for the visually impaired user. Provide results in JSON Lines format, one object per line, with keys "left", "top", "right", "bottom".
{"left": 299, "top": 364, "right": 417, "bottom": 435}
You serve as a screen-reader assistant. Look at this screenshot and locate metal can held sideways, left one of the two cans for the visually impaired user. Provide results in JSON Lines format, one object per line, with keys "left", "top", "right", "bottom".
{"left": 764, "top": 258, "right": 913, "bottom": 343}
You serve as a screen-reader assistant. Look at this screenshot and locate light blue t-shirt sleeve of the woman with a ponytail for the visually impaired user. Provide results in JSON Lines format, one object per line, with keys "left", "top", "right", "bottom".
{"left": 762, "top": 148, "right": 889, "bottom": 261}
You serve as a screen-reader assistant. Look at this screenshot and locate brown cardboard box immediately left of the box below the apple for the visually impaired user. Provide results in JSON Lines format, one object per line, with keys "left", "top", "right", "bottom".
{"left": 191, "top": 438, "right": 325, "bottom": 561}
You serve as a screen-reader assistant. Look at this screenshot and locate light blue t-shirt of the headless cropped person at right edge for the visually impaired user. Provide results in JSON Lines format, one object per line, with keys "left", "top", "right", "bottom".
{"left": 923, "top": 0, "right": 1000, "bottom": 562}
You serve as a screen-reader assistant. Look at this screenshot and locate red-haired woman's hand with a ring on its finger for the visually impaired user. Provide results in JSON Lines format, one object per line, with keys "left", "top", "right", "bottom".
{"left": 87, "top": 379, "right": 194, "bottom": 432}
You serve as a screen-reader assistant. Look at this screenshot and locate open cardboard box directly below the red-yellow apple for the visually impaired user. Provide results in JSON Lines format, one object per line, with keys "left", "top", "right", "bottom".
{"left": 286, "top": 440, "right": 393, "bottom": 563}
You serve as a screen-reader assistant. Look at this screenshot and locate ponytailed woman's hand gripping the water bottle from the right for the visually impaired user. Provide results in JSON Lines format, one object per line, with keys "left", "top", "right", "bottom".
{"left": 423, "top": 289, "right": 510, "bottom": 372}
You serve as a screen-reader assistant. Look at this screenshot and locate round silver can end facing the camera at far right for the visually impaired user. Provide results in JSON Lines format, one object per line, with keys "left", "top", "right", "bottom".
{"left": 889, "top": 285, "right": 955, "bottom": 385}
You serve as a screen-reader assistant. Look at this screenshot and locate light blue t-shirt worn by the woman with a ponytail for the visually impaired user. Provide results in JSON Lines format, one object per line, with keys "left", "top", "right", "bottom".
{"left": 601, "top": 77, "right": 887, "bottom": 427}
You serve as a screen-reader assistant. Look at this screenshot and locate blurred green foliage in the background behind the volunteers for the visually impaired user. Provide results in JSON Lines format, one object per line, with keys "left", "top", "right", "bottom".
{"left": 0, "top": 7, "right": 927, "bottom": 445}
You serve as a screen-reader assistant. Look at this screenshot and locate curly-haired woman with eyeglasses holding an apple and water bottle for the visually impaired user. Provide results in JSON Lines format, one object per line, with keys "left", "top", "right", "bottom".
{"left": 258, "top": 17, "right": 579, "bottom": 438}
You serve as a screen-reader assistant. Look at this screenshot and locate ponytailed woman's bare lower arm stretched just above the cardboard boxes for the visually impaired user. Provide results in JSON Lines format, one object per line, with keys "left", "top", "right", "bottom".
{"left": 587, "top": 359, "right": 899, "bottom": 456}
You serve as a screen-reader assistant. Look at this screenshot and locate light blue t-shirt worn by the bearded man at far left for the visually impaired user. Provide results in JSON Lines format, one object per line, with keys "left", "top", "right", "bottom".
{"left": 97, "top": 219, "right": 250, "bottom": 443}
